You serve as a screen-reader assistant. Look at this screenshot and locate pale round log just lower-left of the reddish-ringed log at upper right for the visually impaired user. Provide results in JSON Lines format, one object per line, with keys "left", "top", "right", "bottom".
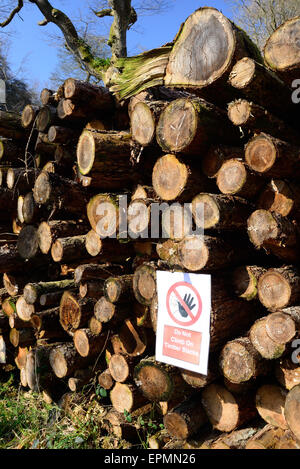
{"left": 217, "top": 159, "right": 265, "bottom": 199}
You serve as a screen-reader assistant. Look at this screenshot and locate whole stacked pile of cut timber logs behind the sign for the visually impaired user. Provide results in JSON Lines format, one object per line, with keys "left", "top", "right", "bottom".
{"left": 0, "top": 8, "right": 300, "bottom": 449}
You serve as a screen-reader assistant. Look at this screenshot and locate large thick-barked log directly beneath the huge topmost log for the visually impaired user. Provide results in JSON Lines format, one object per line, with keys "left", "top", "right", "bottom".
{"left": 156, "top": 98, "right": 238, "bottom": 156}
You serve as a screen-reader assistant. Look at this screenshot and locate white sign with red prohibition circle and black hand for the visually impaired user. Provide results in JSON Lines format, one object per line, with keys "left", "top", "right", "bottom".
{"left": 155, "top": 271, "right": 211, "bottom": 375}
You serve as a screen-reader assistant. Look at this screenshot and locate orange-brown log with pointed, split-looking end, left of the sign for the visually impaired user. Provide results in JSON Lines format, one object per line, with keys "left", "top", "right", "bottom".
{"left": 59, "top": 291, "right": 95, "bottom": 333}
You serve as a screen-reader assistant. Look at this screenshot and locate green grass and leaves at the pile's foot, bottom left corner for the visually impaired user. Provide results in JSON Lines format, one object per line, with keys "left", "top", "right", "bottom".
{"left": 0, "top": 373, "right": 122, "bottom": 449}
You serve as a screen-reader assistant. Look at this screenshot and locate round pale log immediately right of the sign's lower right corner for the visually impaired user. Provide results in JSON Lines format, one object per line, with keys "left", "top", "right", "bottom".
{"left": 219, "top": 337, "right": 269, "bottom": 384}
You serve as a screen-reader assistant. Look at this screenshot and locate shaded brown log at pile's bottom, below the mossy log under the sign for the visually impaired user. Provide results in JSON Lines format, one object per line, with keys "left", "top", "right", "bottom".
{"left": 164, "top": 396, "right": 207, "bottom": 440}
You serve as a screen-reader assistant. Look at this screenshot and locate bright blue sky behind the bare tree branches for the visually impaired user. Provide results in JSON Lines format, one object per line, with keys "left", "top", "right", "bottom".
{"left": 2, "top": 0, "right": 230, "bottom": 89}
